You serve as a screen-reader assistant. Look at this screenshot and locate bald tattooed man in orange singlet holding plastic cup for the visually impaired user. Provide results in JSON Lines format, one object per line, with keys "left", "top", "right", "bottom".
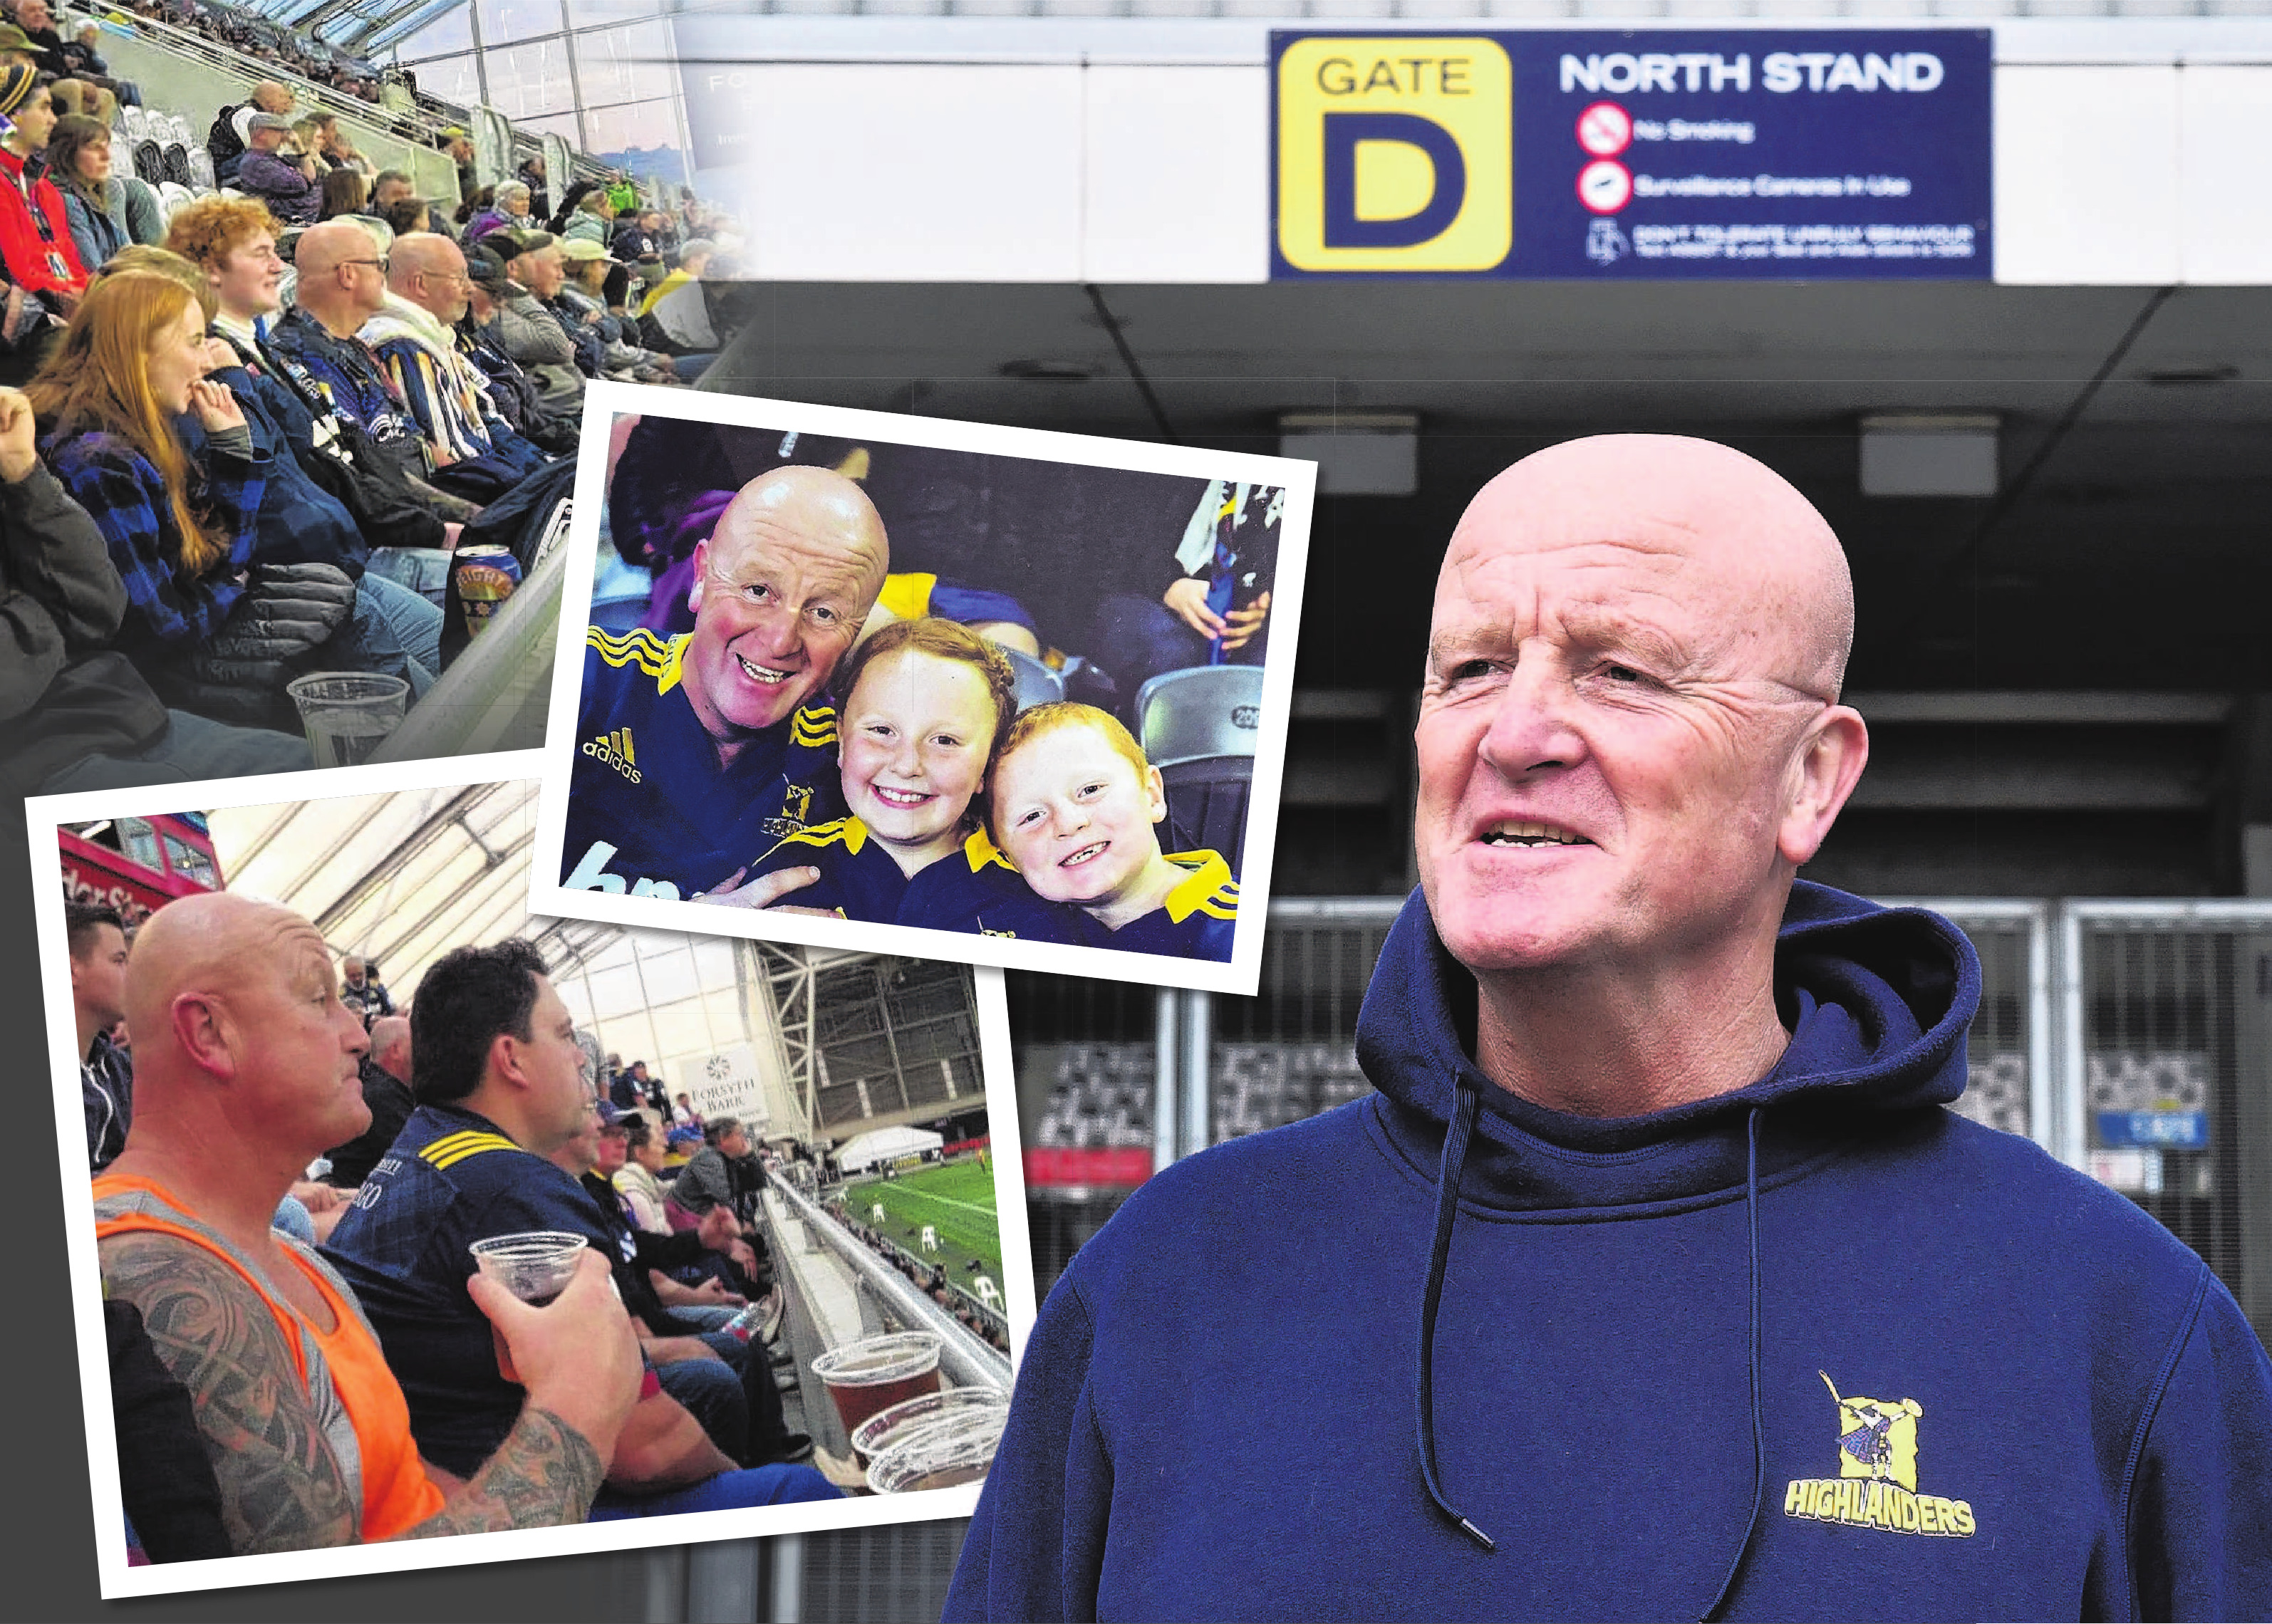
{"left": 95, "top": 892, "right": 640, "bottom": 1556}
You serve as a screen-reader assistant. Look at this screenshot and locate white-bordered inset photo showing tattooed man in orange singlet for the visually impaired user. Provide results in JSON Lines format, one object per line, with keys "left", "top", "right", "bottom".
{"left": 27, "top": 751, "right": 1034, "bottom": 1597}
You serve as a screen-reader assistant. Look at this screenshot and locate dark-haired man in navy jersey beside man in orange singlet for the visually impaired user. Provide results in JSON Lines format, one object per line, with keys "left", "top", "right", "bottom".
{"left": 325, "top": 940, "right": 836, "bottom": 1519}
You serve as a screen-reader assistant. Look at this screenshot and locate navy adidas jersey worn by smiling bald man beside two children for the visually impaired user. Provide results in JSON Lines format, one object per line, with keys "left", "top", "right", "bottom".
{"left": 561, "top": 627, "right": 845, "bottom": 897}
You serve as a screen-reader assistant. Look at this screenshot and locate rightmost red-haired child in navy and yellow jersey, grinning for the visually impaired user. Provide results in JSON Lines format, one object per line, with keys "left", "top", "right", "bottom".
{"left": 945, "top": 704, "right": 1238, "bottom": 961}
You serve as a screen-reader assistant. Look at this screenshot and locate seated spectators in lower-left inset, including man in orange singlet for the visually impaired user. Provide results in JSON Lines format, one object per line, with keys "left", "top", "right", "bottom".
{"left": 80, "top": 892, "right": 856, "bottom": 1561}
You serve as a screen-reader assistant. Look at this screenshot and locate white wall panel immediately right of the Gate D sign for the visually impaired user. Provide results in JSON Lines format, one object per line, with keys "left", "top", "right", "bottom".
{"left": 1995, "top": 66, "right": 2181, "bottom": 286}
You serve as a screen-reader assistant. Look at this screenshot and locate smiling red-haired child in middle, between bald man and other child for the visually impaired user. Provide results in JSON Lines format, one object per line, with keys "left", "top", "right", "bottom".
{"left": 705, "top": 615, "right": 1018, "bottom": 922}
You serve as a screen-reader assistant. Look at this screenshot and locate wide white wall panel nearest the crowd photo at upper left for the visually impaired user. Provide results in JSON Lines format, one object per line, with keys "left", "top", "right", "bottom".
{"left": 743, "top": 63, "right": 1081, "bottom": 281}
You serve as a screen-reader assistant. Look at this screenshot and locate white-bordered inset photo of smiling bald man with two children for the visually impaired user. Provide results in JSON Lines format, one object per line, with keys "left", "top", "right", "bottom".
{"left": 529, "top": 384, "right": 1315, "bottom": 993}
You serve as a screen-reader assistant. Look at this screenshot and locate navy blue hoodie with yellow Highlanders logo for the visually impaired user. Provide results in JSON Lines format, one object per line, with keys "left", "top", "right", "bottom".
{"left": 948, "top": 883, "right": 2272, "bottom": 1620}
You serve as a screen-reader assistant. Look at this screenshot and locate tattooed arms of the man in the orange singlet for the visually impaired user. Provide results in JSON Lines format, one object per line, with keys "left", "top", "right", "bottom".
{"left": 100, "top": 1231, "right": 638, "bottom": 1556}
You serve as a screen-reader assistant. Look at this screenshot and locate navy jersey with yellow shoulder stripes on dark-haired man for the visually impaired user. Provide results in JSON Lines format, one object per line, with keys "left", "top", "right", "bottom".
{"left": 323, "top": 1106, "right": 621, "bottom": 1477}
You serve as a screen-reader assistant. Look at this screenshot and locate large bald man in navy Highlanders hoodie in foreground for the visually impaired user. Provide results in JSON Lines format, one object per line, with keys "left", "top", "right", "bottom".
{"left": 948, "top": 436, "right": 2272, "bottom": 1620}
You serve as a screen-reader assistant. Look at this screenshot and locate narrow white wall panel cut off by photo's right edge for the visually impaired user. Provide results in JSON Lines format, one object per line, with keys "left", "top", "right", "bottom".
{"left": 2177, "top": 66, "right": 2272, "bottom": 284}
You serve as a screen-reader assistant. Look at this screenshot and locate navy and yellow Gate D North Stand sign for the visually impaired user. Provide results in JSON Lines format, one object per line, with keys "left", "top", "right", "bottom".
{"left": 1270, "top": 29, "right": 1991, "bottom": 281}
